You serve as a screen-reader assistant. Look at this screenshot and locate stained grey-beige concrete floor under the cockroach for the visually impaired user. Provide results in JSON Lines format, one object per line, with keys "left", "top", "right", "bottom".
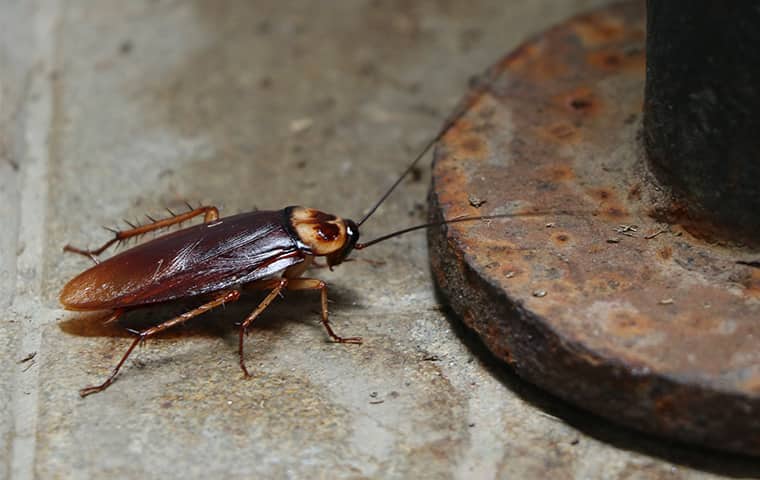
{"left": 0, "top": 0, "right": 760, "bottom": 479}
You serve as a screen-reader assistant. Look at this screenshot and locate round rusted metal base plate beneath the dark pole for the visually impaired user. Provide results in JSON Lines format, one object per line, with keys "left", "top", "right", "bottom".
{"left": 429, "top": 1, "right": 760, "bottom": 455}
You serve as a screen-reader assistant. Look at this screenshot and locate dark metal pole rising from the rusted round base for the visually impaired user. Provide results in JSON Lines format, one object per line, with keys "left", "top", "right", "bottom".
{"left": 644, "top": 0, "right": 760, "bottom": 242}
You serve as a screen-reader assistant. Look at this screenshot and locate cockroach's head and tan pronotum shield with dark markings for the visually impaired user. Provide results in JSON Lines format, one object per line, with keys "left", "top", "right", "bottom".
{"left": 286, "top": 207, "right": 359, "bottom": 267}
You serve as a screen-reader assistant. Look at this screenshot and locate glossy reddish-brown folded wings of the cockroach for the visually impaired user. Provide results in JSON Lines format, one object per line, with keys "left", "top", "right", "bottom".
{"left": 60, "top": 211, "right": 305, "bottom": 310}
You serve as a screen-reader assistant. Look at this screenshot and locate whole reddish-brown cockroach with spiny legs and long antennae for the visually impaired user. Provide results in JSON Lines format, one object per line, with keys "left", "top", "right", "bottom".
{"left": 60, "top": 88, "right": 494, "bottom": 397}
